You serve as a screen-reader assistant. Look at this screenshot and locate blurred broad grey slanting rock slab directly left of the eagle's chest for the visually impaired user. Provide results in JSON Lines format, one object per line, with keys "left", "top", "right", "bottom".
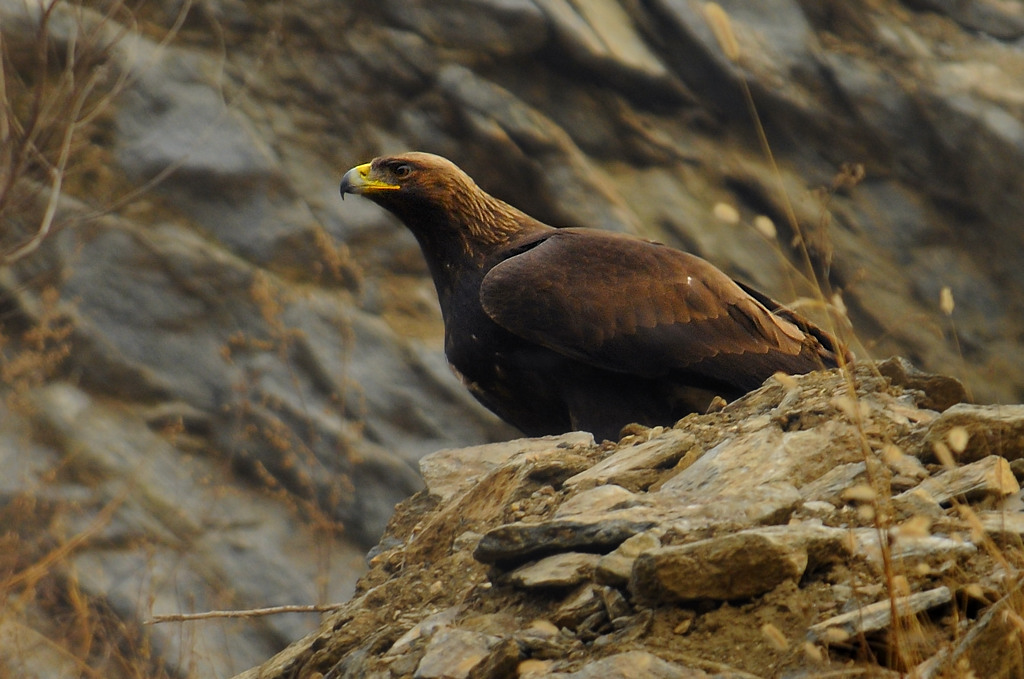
{"left": 4, "top": 210, "right": 477, "bottom": 545}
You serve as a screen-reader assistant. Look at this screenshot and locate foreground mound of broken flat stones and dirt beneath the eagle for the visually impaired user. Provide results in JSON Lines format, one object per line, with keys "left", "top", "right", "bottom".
{"left": 238, "top": 362, "right": 1024, "bottom": 679}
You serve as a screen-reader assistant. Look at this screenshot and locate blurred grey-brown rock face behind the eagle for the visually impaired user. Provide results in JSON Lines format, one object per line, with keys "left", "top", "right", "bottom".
{"left": 0, "top": 0, "right": 1024, "bottom": 677}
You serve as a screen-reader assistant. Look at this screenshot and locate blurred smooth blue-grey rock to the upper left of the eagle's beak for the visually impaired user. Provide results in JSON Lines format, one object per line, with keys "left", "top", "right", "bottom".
{"left": 116, "top": 43, "right": 322, "bottom": 267}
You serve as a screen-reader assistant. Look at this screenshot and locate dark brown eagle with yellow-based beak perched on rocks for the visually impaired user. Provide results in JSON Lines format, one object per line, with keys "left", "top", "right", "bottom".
{"left": 341, "top": 153, "right": 849, "bottom": 438}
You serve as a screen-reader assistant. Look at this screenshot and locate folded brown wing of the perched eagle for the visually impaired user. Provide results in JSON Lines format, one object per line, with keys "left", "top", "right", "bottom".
{"left": 480, "top": 228, "right": 822, "bottom": 390}
